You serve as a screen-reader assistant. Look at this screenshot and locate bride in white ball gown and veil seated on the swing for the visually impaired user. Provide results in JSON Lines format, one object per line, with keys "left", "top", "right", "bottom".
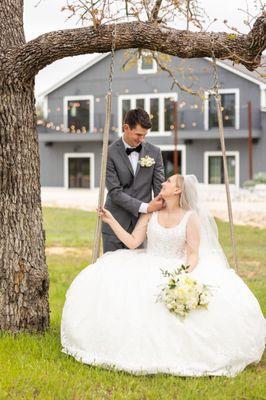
{"left": 61, "top": 175, "right": 266, "bottom": 377}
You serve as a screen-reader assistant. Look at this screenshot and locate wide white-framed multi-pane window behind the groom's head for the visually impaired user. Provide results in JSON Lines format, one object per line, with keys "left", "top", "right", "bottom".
{"left": 118, "top": 93, "right": 177, "bottom": 135}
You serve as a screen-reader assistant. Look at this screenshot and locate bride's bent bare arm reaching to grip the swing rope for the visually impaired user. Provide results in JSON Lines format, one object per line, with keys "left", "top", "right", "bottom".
{"left": 99, "top": 209, "right": 150, "bottom": 249}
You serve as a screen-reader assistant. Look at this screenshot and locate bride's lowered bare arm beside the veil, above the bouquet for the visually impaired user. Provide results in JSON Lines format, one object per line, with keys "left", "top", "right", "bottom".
{"left": 186, "top": 213, "right": 200, "bottom": 272}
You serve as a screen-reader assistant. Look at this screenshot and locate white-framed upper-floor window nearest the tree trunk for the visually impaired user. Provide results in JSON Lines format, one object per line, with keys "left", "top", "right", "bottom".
{"left": 64, "top": 96, "right": 93, "bottom": 133}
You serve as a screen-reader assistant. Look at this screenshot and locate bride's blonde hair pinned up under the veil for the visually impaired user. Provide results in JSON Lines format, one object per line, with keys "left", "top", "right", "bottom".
{"left": 176, "top": 175, "right": 198, "bottom": 210}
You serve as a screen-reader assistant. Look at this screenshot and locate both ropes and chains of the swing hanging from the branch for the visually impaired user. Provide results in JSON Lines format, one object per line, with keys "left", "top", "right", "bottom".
{"left": 92, "top": 32, "right": 238, "bottom": 271}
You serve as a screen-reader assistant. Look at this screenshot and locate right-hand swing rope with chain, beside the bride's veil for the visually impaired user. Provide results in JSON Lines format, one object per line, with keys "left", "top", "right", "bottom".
{"left": 211, "top": 37, "right": 238, "bottom": 272}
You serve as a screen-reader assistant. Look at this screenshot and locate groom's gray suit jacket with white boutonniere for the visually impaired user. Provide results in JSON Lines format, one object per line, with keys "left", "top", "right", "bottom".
{"left": 102, "top": 138, "right": 164, "bottom": 247}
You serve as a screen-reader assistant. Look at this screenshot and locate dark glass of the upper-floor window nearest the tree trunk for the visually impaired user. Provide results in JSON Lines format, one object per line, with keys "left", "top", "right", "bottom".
{"left": 67, "top": 100, "right": 90, "bottom": 132}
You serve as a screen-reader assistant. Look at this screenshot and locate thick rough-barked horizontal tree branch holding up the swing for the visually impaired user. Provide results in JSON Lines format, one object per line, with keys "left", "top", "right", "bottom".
{"left": 4, "top": 13, "right": 266, "bottom": 81}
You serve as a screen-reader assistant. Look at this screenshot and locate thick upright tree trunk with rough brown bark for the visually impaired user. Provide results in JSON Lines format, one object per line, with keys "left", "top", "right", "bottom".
{"left": 0, "top": 0, "right": 49, "bottom": 332}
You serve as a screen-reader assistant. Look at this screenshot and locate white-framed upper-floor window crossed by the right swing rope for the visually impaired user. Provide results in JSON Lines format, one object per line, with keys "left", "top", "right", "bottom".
{"left": 204, "top": 89, "right": 239, "bottom": 130}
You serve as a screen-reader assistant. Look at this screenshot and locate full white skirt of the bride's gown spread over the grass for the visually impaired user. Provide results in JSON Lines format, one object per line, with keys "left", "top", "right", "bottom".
{"left": 61, "top": 250, "right": 266, "bottom": 377}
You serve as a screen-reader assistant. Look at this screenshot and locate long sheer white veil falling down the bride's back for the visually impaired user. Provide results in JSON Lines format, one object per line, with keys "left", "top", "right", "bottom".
{"left": 180, "top": 175, "right": 230, "bottom": 268}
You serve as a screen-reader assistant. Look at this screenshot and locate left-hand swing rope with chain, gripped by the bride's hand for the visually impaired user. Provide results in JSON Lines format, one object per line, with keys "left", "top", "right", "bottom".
{"left": 92, "top": 24, "right": 116, "bottom": 263}
